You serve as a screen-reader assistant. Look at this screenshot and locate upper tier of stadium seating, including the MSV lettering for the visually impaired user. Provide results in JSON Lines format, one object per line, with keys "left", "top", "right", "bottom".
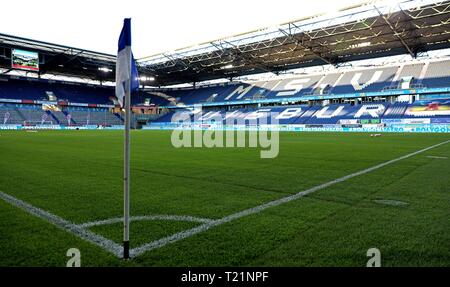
{"left": 0, "top": 60, "right": 450, "bottom": 109}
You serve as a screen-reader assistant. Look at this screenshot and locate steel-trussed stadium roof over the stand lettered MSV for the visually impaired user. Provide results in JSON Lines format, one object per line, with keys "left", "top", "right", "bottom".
{"left": 138, "top": 0, "right": 450, "bottom": 86}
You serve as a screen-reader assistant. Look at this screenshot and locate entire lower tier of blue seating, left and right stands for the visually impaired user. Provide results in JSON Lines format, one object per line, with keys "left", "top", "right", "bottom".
{"left": 5, "top": 99, "right": 450, "bottom": 125}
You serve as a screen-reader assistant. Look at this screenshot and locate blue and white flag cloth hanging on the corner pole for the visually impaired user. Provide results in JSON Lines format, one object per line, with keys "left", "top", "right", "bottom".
{"left": 116, "top": 19, "right": 139, "bottom": 107}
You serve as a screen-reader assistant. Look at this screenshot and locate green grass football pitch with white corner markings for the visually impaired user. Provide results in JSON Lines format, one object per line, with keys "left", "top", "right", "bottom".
{"left": 0, "top": 131, "right": 450, "bottom": 267}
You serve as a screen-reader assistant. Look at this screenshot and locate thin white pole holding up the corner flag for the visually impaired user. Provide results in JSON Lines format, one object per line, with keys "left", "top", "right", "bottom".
{"left": 123, "top": 58, "right": 131, "bottom": 259}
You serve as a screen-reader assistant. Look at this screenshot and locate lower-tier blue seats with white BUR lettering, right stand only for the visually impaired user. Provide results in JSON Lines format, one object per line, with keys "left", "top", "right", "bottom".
{"left": 151, "top": 99, "right": 450, "bottom": 125}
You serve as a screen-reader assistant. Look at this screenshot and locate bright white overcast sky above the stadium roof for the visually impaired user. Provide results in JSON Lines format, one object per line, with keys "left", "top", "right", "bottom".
{"left": 0, "top": 0, "right": 364, "bottom": 58}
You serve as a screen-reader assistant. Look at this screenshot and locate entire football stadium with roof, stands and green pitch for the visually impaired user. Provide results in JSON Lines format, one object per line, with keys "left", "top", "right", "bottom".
{"left": 0, "top": 0, "right": 450, "bottom": 267}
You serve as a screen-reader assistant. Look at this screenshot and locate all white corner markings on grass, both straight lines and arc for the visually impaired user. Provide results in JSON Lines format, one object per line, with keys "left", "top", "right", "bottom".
{"left": 0, "top": 140, "right": 450, "bottom": 258}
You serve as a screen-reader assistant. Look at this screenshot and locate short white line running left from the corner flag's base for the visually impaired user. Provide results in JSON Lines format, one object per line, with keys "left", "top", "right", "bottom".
{"left": 0, "top": 191, "right": 123, "bottom": 257}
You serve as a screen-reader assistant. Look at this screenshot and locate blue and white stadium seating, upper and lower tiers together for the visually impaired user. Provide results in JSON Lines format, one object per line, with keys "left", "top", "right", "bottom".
{"left": 0, "top": 59, "right": 450, "bottom": 130}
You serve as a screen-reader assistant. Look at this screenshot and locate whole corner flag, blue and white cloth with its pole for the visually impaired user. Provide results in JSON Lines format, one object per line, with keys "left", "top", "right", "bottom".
{"left": 116, "top": 19, "right": 139, "bottom": 258}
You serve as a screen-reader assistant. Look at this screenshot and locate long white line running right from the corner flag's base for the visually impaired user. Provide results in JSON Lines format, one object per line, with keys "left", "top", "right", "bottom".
{"left": 130, "top": 140, "right": 450, "bottom": 257}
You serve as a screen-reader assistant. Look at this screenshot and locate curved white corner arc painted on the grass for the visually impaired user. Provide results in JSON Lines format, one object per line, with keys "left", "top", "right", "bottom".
{"left": 78, "top": 215, "right": 213, "bottom": 228}
